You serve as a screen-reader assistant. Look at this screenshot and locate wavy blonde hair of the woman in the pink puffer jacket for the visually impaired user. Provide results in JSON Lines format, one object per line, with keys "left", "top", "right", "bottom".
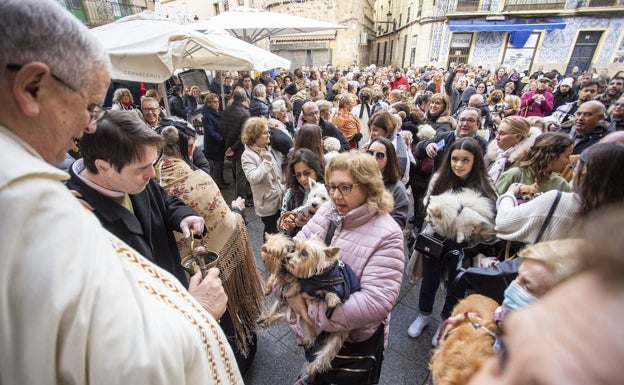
{"left": 325, "top": 150, "right": 394, "bottom": 213}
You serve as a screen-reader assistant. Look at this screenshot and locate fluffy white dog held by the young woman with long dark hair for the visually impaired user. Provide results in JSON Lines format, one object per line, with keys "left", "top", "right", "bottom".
{"left": 425, "top": 189, "right": 494, "bottom": 243}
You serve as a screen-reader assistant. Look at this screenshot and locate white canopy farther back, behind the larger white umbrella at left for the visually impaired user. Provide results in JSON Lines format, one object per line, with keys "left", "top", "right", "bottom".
{"left": 189, "top": 7, "right": 347, "bottom": 43}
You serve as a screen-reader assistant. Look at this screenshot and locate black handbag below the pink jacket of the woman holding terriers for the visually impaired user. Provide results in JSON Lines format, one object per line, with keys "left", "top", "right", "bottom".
{"left": 305, "top": 324, "right": 384, "bottom": 385}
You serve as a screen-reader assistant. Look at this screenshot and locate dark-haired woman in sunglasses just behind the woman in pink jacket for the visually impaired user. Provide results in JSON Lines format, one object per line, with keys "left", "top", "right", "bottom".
{"left": 366, "top": 136, "right": 409, "bottom": 229}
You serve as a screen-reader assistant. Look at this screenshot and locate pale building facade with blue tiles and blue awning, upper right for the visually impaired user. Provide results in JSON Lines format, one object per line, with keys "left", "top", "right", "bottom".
{"left": 370, "top": 0, "right": 624, "bottom": 73}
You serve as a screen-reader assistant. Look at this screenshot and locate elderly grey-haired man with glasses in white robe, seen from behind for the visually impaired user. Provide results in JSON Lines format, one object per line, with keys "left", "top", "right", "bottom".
{"left": 0, "top": 0, "right": 243, "bottom": 385}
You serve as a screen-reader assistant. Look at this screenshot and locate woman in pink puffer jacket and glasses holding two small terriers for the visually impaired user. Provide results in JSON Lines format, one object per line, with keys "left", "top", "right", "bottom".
{"left": 288, "top": 151, "right": 404, "bottom": 385}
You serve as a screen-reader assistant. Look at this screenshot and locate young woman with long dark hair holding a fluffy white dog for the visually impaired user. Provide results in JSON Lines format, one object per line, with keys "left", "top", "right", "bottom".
{"left": 407, "top": 138, "right": 496, "bottom": 346}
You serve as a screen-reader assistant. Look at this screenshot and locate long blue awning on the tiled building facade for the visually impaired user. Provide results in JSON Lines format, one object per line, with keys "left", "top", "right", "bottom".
{"left": 449, "top": 19, "right": 566, "bottom": 32}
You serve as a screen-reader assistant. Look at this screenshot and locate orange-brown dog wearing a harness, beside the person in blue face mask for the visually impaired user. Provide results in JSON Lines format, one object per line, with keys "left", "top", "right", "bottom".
{"left": 429, "top": 294, "right": 500, "bottom": 385}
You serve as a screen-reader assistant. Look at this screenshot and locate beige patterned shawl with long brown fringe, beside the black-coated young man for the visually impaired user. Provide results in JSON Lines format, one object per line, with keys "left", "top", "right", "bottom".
{"left": 159, "top": 158, "right": 264, "bottom": 356}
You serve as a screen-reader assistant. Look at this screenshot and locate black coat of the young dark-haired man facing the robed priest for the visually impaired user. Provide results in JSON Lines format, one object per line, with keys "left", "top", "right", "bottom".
{"left": 67, "top": 170, "right": 198, "bottom": 286}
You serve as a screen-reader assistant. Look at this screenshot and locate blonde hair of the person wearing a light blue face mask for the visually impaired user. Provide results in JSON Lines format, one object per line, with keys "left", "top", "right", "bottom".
{"left": 518, "top": 238, "right": 586, "bottom": 289}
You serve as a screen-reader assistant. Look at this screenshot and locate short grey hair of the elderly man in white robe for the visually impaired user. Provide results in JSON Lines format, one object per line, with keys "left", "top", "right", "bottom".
{"left": 0, "top": 0, "right": 110, "bottom": 89}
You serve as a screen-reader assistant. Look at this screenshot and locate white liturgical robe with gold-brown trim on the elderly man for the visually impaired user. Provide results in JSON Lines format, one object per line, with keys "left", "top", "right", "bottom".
{"left": 0, "top": 126, "right": 243, "bottom": 385}
